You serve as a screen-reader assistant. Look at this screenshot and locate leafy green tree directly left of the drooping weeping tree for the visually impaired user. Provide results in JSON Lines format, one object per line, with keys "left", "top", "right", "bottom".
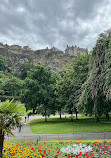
{"left": 56, "top": 53, "right": 90, "bottom": 118}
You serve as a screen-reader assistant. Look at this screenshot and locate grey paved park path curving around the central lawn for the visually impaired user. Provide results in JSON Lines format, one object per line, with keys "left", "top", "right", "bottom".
{"left": 5, "top": 115, "right": 111, "bottom": 141}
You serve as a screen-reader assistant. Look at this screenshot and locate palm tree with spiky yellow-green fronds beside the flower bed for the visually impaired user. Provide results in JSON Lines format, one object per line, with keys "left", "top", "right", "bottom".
{"left": 0, "top": 100, "right": 21, "bottom": 158}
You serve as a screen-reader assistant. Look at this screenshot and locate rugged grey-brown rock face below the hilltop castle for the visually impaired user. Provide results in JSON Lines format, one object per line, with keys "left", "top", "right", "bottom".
{"left": 0, "top": 43, "right": 88, "bottom": 73}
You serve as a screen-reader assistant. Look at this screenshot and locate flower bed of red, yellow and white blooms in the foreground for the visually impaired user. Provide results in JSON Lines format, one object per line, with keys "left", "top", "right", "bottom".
{"left": 3, "top": 141, "right": 111, "bottom": 158}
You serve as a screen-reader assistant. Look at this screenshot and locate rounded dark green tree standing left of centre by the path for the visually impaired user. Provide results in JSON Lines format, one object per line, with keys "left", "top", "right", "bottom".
{"left": 21, "top": 66, "right": 55, "bottom": 121}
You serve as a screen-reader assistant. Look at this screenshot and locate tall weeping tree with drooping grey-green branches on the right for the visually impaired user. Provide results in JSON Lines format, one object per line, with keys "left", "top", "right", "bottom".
{"left": 80, "top": 33, "right": 110, "bottom": 122}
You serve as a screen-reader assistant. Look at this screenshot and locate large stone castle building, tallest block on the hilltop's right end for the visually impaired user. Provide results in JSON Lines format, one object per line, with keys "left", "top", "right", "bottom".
{"left": 65, "top": 45, "right": 88, "bottom": 56}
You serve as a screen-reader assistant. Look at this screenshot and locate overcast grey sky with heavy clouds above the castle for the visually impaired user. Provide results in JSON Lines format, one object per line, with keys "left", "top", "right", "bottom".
{"left": 0, "top": 0, "right": 111, "bottom": 50}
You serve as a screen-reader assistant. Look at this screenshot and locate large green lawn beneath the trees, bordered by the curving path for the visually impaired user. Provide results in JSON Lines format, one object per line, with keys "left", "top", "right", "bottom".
{"left": 30, "top": 117, "right": 111, "bottom": 134}
